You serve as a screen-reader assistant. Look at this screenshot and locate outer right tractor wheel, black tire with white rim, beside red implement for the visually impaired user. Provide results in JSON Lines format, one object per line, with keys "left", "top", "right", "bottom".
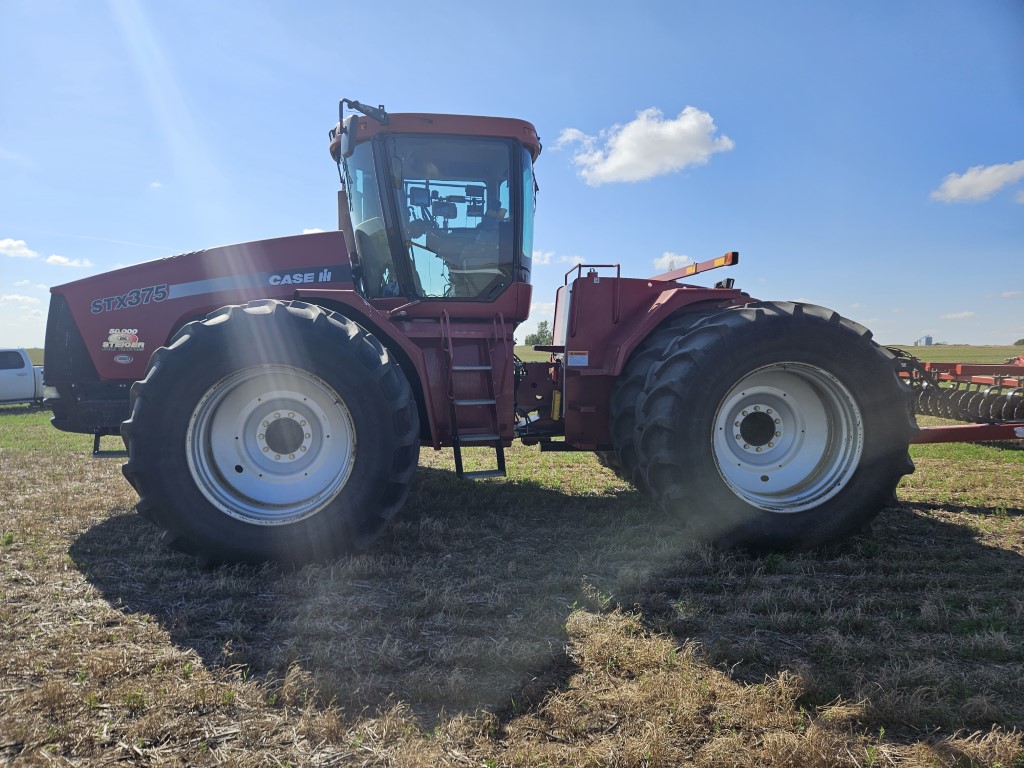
{"left": 636, "top": 302, "right": 915, "bottom": 550}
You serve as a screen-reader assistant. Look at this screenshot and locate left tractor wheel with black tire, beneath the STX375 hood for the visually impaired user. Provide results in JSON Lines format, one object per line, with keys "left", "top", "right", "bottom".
{"left": 121, "top": 300, "right": 420, "bottom": 564}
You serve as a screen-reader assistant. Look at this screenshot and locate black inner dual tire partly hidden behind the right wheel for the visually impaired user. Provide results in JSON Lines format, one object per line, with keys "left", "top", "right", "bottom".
{"left": 597, "top": 309, "right": 721, "bottom": 493}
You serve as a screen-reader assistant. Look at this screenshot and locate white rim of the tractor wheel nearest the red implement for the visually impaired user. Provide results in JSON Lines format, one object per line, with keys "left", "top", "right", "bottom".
{"left": 712, "top": 362, "right": 864, "bottom": 513}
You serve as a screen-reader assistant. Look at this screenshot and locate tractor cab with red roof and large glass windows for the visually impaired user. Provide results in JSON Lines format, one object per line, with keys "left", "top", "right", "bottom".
{"left": 331, "top": 99, "right": 541, "bottom": 302}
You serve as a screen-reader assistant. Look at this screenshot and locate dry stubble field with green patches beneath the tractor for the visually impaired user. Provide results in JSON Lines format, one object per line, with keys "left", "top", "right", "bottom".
{"left": 0, "top": 406, "right": 1024, "bottom": 767}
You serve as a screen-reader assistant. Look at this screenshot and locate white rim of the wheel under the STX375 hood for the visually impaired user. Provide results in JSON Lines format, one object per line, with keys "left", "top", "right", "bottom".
{"left": 185, "top": 366, "right": 355, "bottom": 525}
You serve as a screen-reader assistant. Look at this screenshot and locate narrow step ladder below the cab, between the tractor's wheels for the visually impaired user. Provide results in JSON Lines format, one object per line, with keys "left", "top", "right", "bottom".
{"left": 441, "top": 312, "right": 506, "bottom": 479}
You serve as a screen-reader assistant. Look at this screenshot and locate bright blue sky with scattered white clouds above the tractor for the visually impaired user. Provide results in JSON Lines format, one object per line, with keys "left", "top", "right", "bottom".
{"left": 0, "top": 0, "right": 1024, "bottom": 346}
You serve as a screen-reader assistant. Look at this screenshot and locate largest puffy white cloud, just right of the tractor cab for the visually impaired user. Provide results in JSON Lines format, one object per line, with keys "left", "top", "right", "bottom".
{"left": 555, "top": 106, "right": 735, "bottom": 186}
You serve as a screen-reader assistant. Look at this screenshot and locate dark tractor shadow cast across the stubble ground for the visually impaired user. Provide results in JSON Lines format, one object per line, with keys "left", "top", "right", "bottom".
{"left": 71, "top": 465, "right": 1024, "bottom": 728}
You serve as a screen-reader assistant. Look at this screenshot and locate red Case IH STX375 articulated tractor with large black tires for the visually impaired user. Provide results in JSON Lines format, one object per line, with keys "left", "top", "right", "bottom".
{"left": 45, "top": 99, "right": 915, "bottom": 562}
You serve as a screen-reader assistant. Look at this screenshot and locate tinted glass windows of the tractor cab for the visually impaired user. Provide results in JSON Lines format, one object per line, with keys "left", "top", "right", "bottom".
{"left": 346, "top": 136, "right": 534, "bottom": 300}
